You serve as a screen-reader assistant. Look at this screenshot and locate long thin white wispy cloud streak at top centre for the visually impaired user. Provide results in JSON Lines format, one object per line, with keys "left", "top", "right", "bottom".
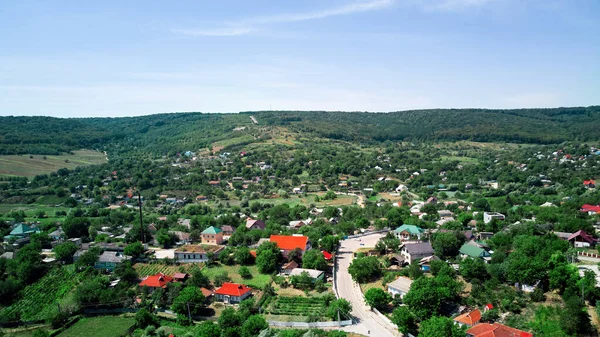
{"left": 171, "top": 0, "right": 396, "bottom": 36}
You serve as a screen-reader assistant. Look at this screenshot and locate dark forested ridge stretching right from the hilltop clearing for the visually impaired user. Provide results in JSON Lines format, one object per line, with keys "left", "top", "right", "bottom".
{"left": 253, "top": 106, "right": 600, "bottom": 143}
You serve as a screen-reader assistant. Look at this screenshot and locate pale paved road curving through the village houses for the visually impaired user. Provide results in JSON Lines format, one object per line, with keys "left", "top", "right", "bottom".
{"left": 336, "top": 234, "right": 401, "bottom": 337}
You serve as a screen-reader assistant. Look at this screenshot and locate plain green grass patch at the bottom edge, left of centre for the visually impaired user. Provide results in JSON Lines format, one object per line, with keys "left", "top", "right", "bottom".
{"left": 58, "top": 316, "right": 135, "bottom": 337}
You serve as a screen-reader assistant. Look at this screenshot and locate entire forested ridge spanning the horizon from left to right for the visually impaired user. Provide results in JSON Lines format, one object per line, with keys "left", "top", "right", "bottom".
{"left": 0, "top": 106, "right": 600, "bottom": 154}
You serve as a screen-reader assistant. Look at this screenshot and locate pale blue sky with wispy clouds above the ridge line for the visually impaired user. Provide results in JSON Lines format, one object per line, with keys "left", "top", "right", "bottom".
{"left": 0, "top": 0, "right": 600, "bottom": 117}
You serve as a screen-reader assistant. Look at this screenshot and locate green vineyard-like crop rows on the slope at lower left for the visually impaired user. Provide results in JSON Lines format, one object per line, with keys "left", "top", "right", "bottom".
{"left": 0, "top": 265, "right": 84, "bottom": 321}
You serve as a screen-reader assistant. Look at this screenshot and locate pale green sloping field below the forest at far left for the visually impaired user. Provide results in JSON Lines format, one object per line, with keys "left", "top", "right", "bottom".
{"left": 0, "top": 150, "right": 107, "bottom": 177}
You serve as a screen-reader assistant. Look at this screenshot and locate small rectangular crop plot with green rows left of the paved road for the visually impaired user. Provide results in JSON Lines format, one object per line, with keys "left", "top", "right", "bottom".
{"left": 266, "top": 296, "right": 330, "bottom": 316}
